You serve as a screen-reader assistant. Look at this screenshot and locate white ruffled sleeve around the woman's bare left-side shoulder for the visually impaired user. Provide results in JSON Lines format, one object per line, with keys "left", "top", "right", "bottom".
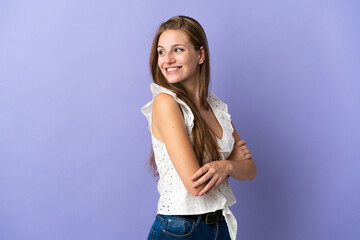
{"left": 141, "top": 83, "right": 194, "bottom": 138}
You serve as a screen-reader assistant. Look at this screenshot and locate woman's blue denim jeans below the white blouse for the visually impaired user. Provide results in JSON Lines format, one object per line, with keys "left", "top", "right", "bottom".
{"left": 147, "top": 214, "right": 230, "bottom": 240}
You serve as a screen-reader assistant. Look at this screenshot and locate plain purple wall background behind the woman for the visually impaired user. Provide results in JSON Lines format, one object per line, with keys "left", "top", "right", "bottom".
{"left": 0, "top": 0, "right": 360, "bottom": 240}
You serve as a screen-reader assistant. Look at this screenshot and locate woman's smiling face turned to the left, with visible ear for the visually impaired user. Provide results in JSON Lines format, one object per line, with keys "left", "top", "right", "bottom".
{"left": 157, "top": 30, "right": 205, "bottom": 83}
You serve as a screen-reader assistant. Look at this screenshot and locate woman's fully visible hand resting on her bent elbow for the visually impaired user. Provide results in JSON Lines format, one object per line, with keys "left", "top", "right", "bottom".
{"left": 191, "top": 160, "right": 230, "bottom": 196}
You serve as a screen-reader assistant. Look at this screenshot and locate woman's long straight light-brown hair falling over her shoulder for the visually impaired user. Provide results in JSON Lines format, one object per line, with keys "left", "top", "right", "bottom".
{"left": 148, "top": 16, "right": 220, "bottom": 177}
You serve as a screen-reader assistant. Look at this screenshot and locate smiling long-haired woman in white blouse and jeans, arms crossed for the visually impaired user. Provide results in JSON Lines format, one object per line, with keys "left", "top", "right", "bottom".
{"left": 141, "top": 16, "right": 257, "bottom": 240}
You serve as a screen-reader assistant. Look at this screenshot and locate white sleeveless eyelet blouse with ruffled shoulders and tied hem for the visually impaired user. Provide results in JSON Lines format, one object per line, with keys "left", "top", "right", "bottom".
{"left": 141, "top": 83, "right": 237, "bottom": 240}
